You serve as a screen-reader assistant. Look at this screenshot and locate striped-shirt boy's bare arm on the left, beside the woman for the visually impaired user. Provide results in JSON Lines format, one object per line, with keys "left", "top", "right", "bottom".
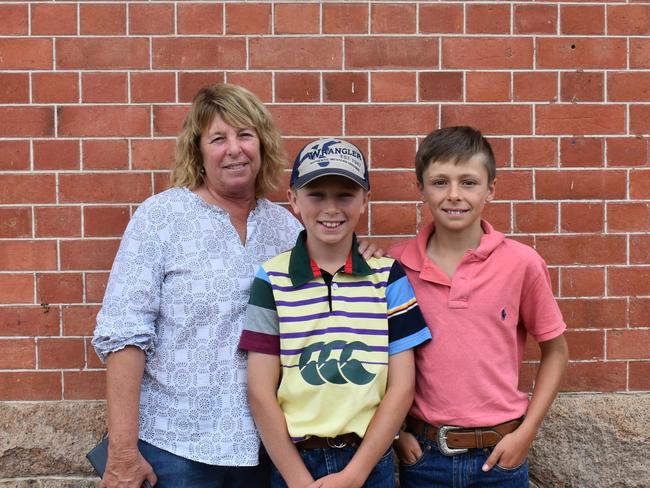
{"left": 248, "top": 351, "right": 314, "bottom": 488}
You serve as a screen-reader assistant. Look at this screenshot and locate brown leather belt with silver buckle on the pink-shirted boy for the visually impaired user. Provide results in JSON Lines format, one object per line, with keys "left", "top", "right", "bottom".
{"left": 406, "top": 415, "right": 523, "bottom": 456}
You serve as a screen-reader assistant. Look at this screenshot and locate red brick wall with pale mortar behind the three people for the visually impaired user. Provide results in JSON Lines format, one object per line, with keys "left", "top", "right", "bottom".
{"left": 0, "top": 0, "right": 650, "bottom": 400}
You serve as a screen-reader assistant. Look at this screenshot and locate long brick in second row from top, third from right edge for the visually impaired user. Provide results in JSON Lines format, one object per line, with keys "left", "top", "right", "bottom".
{"left": 442, "top": 37, "right": 533, "bottom": 69}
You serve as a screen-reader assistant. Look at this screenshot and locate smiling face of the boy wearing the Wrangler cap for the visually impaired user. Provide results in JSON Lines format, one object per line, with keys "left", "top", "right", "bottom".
{"left": 287, "top": 175, "right": 368, "bottom": 253}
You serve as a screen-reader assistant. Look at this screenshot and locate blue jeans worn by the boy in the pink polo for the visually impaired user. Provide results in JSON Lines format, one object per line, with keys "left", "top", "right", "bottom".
{"left": 399, "top": 436, "right": 528, "bottom": 488}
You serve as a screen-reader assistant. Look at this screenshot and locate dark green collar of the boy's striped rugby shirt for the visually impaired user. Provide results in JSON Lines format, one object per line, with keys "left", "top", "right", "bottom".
{"left": 289, "top": 230, "right": 373, "bottom": 288}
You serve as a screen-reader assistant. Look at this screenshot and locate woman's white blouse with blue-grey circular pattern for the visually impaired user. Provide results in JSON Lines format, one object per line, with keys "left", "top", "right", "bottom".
{"left": 93, "top": 188, "right": 301, "bottom": 466}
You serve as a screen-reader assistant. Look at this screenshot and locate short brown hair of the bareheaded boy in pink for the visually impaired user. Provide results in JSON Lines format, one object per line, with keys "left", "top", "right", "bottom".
{"left": 415, "top": 126, "right": 497, "bottom": 185}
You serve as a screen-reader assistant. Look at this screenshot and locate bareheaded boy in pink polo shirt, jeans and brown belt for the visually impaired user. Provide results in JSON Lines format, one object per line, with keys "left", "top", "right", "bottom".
{"left": 389, "top": 127, "right": 568, "bottom": 488}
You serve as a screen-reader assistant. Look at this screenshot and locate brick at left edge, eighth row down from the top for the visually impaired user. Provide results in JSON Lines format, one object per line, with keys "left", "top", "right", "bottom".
{"left": 0, "top": 240, "right": 56, "bottom": 271}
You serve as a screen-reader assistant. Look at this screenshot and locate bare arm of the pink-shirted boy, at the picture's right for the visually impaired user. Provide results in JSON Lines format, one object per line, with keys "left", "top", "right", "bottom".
{"left": 483, "top": 335, "right": 569, "bottom": 471}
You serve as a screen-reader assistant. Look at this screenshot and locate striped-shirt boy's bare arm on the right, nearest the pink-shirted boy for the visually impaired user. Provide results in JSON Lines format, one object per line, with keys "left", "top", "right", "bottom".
{"left": 311, "top": 349, "right": 415, "bottom": 488}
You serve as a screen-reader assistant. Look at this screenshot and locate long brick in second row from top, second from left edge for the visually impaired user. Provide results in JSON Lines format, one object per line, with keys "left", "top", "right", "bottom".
{"left": 56, "top": 37, "right": 149, "bottom": 70}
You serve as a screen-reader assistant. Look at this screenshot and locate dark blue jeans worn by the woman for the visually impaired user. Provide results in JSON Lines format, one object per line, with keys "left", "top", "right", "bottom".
{"left": 138, "top": 440, "right": 270, "bottom": 488}
